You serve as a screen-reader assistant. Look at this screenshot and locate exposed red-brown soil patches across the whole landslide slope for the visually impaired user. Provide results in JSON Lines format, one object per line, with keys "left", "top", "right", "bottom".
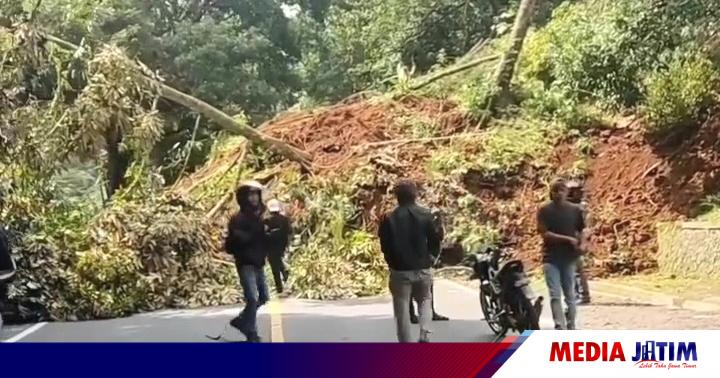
{"left": 214, "top": 97, "right": 720, "bottom": 276}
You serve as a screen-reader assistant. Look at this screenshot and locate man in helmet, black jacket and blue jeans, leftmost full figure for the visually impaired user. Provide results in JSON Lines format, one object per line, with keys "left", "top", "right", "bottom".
{"left": 225, "top": 181, "right": 269, "bottom": 342}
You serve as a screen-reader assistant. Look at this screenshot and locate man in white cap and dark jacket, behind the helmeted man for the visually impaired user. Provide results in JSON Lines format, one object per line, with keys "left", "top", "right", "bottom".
{"left": 265, "top": 199, "right": 292, "bottom": 294}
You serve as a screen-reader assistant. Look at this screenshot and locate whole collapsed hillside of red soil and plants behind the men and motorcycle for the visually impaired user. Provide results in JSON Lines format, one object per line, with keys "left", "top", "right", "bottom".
{"left": 179, "top": 92, "right": 720, "bottom": 298}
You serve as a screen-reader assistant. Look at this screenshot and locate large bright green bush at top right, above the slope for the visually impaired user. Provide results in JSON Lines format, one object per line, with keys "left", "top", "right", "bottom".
{"left": 520, "top": 0, "right": 716, "bottom": 109}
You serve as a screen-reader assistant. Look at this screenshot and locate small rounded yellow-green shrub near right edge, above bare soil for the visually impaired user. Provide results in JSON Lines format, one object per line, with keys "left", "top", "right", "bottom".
{"left": 645, "top": 48, "right": 718, "bottom": 134}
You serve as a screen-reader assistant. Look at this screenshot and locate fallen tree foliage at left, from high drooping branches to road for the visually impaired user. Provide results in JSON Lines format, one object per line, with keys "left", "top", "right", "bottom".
{"left": 0, "top": 25, "right": 237, "bottom": 319}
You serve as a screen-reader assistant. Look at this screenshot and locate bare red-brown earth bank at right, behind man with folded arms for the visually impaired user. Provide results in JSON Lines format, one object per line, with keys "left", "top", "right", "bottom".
{"left": 505, "top": 117, "right": 720, "bottom": 275}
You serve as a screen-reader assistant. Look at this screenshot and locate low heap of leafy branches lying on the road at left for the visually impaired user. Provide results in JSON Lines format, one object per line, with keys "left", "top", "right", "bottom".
{"left": 5, "top": 185, "right": 238, "bottom": 319}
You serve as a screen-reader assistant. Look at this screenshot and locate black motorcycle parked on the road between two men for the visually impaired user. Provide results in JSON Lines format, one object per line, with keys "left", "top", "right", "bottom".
{"left": 471, "top": 247, "right": 543, "bottom": 339}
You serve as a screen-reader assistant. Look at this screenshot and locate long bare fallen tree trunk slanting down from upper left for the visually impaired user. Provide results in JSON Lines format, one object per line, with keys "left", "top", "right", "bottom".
{"left": 43, "top": 34, "right": 312, "bottom": 169}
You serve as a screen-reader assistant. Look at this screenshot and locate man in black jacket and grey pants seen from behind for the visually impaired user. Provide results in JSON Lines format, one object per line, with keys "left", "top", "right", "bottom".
{"left": 378, "top": 180, "right": 442, "bottom": 342}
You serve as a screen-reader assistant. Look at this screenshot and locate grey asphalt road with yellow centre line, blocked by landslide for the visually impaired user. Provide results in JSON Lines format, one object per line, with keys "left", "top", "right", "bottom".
{"left": 0, "top": 280, "right": 551, "bottom": 342}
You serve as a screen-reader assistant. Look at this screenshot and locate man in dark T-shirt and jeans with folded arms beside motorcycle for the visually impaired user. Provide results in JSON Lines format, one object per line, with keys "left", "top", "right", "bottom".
{"left": 537, "top": 179, "right": 585, "bottom": 329}
